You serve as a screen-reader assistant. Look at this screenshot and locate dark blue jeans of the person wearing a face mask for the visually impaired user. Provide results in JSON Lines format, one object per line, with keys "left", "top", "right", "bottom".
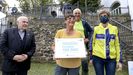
{"left": 93, "top": 56, "right": 116, "bottom": 75}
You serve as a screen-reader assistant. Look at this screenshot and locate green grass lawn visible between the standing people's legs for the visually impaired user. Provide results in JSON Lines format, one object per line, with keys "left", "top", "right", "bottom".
{"left": 0, "top": 63, "right": 128, "bottom": 75}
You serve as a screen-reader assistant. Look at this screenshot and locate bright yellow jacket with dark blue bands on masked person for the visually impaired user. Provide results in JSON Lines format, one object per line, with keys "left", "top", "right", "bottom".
{"left": 90, "top": 23, "right": 120, "bottom": 62}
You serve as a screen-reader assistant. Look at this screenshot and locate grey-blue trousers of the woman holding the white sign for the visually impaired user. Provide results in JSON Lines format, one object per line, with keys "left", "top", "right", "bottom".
{"left": 55, "top": 65, "right": 80, "bottom": 75}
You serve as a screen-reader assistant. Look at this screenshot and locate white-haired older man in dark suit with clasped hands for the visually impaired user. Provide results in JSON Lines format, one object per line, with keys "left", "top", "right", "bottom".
{"left": 0, "top": 16, "right": 36, "bottom": 75}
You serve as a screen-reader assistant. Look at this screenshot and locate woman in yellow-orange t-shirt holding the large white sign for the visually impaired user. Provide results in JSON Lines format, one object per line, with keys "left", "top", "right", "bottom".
{"left": 52, "top": 15, "right": 84, "bottom": 75}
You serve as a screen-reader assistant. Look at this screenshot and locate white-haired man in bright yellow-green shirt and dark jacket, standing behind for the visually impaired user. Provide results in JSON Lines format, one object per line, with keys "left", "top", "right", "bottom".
{"left": 73, "top": 8, "right": 93, "bottom": 75}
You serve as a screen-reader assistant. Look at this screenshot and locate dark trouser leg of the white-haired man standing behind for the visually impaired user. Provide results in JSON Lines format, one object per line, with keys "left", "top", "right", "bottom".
{"left": 81, "top": 57, "right": 89, "bottom": 75}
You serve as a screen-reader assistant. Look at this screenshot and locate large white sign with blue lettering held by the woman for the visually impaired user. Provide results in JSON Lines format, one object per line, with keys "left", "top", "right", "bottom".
{"left": 54, "top": 38, "right": 87, "bottom": 58}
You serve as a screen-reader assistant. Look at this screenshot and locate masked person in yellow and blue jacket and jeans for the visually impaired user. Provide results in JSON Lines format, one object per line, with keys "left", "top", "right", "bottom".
{"left": 90, "top": 9, "right": 122, "bottom": 75}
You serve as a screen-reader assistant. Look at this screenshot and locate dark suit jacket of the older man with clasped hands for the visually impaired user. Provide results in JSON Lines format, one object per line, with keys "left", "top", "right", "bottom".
{"left": 0, "top": 28, "right": 36, "bottom": 72}
